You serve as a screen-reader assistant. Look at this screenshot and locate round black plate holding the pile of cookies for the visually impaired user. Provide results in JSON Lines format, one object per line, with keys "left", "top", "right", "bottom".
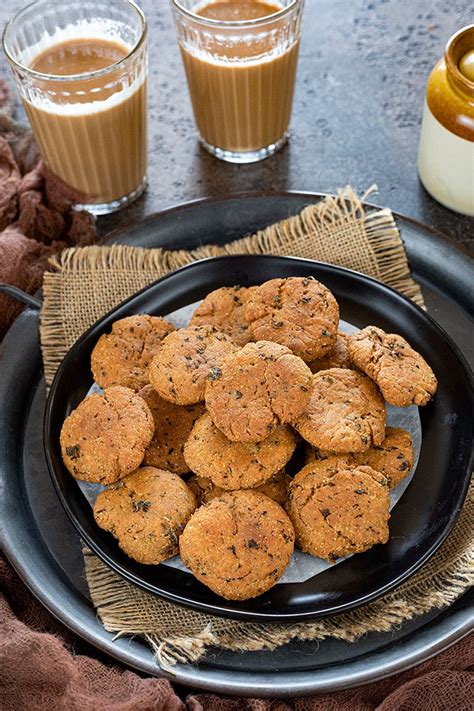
{"left": 44, "top": 256, "right": 474, "bottom": 621}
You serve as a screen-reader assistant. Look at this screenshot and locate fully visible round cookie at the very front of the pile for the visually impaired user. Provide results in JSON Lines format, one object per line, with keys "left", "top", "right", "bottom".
{"left": 179, "top": 490, "right": 294, "bottom": 600}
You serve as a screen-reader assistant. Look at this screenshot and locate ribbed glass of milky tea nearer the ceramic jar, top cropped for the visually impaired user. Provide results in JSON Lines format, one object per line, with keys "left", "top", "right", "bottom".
{"left": 171, "top": 0, "right": 304, "bottom": 163}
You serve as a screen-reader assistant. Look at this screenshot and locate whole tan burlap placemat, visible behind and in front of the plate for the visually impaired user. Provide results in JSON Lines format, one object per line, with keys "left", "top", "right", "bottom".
{"left": 40, "top": 188, "right": 474, "bottom": 670}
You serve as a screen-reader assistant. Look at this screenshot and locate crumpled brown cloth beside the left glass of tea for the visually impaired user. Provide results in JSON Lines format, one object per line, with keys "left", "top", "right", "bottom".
{"left": 0, "top": 77, "right": 95, "bottom": 340}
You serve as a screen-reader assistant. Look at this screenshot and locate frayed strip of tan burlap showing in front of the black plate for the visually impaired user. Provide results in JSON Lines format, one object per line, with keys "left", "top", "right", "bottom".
{"left": 84, "top": 483, "right": 474, "bottom": 672}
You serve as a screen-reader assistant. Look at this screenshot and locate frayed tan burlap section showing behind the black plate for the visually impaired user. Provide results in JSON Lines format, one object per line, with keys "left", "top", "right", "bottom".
{"left": 40, "top": 186, "right": 424, "bottom": 385}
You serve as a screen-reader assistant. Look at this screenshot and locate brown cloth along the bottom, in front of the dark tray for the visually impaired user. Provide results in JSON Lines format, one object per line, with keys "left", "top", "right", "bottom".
{"left": 0, "top": 561, "right": 474, "bottom": 711}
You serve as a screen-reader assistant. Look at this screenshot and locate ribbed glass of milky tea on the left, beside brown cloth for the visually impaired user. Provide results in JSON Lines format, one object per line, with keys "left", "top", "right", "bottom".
{"left": 3, "top": 0, "right": 147, "bottom": 215}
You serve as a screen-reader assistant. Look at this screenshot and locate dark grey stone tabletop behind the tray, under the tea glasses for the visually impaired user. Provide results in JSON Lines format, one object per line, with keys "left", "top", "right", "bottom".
{"left": 0, "top": 0, "right": 474, "bottom": 248}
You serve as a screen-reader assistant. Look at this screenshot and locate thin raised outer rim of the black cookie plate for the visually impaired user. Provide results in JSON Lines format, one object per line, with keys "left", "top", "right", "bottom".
{"left": 43, "top": 256, "right": 474, "bottom": 622}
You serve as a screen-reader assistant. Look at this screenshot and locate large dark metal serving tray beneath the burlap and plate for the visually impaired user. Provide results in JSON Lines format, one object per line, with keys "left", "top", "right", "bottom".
{"left": 0, "top": 194, "right": 474, "bottom": 696}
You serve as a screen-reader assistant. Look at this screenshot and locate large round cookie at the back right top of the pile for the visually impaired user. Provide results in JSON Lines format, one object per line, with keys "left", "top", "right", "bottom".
{"left": 244, "top": 277, "right": 339, "bottom": 361}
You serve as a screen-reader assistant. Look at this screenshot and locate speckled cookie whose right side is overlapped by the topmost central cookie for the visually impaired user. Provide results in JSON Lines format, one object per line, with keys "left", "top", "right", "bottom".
{"left": 148, "top": 326, "right": 236, "bottom": 405}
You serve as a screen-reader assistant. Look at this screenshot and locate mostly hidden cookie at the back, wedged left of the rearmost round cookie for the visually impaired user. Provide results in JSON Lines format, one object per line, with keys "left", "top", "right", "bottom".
{"left": 189, "top": 286, "right": 256, "bottom": 347}
